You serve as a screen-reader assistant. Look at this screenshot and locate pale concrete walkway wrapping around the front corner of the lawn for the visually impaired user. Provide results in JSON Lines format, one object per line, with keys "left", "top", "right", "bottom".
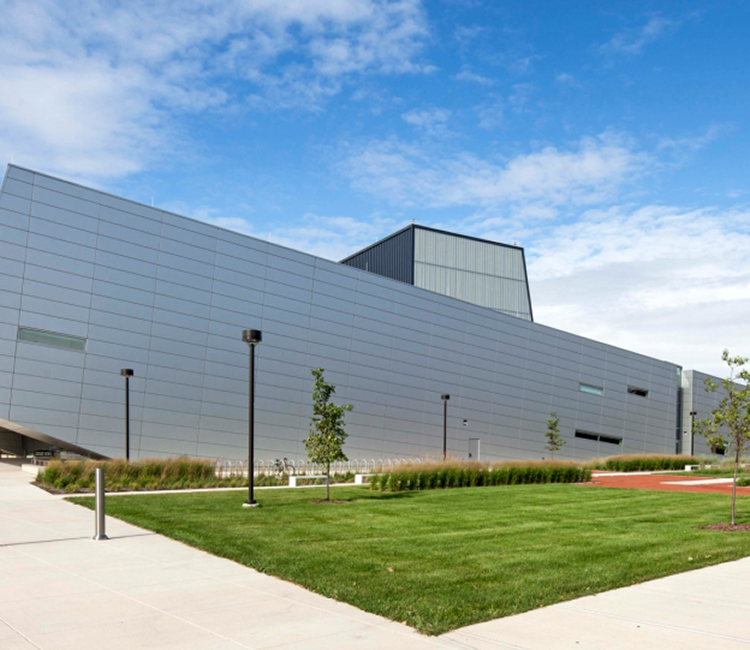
{"left": 0, "top": 462, "right": 750, "bottom": 650}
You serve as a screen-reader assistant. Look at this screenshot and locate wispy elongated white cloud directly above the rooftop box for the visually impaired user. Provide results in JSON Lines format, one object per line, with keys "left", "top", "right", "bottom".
{"left": 340, "top": 134, "right": 650, "bottom": 207}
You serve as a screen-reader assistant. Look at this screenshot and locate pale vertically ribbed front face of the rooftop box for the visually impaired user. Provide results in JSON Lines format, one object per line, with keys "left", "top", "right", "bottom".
{"left": 414, "top": 228, "right": 532, "bottom": 320}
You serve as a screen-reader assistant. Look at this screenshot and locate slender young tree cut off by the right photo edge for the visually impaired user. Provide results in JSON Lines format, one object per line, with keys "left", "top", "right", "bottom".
{"left": 697, "top": 350, "right": 750, "bottom": 526}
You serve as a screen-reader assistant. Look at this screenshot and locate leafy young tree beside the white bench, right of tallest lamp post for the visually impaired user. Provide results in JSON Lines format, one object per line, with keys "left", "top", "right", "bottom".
{"left": 305, "top": 368, "right": 353, "bottom": 501}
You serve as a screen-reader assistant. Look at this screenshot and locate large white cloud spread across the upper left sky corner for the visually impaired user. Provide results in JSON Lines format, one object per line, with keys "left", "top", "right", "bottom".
{"left": 0, "top": 0, "right": 433, "bottom": 182}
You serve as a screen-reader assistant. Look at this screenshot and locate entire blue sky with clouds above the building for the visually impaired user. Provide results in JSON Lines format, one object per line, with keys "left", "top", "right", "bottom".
{"left": 0, "top": 0, "right": 750, "bottom": 374}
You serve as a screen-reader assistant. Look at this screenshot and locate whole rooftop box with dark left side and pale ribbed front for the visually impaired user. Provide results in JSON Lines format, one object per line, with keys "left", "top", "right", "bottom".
{"left": 341, "top": 224, "right": 534, "bottom": 320}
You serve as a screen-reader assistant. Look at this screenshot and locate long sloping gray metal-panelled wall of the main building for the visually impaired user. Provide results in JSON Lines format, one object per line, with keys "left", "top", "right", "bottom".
{"left": 0, "top": 166, "right": 679, "bottom": 460}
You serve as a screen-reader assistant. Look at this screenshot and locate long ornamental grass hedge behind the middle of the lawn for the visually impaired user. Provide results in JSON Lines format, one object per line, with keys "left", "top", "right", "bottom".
{"left": 370, "top": 462, "right": 591, "bottom": 492}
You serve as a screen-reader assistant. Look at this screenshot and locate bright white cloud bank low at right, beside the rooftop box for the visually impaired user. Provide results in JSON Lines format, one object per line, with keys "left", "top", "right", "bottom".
{"left": 527, "top": 206, "right": 750, "bottom": 374}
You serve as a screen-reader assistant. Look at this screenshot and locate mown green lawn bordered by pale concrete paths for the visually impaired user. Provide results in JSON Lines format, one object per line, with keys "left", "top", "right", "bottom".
{"left": 71, "top": 484, "right": 750, "bottom": 634}
